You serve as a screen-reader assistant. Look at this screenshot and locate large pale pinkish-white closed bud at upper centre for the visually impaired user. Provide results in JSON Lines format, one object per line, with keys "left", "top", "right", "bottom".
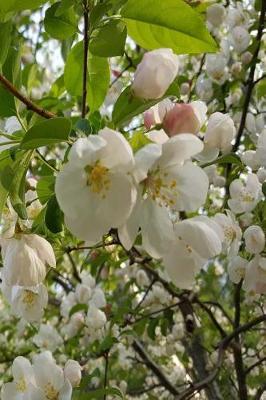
{"left": 132, "top": 49, "right": 178, "bottom": 99}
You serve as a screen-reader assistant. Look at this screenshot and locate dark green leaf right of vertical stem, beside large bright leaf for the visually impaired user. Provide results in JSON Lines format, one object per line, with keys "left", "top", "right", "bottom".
{"left": 90, "top": 20, "right": 127, "bottom": 57}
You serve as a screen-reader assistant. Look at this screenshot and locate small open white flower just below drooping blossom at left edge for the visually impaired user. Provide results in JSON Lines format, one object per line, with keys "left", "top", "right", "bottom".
{"left": 11, "top": 284, "right": 48, "bottom": 322}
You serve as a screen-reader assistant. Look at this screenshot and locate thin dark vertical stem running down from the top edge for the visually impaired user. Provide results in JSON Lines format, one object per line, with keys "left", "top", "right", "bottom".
{"left": 81, "top": 0, "right": 89, "bottom": 118}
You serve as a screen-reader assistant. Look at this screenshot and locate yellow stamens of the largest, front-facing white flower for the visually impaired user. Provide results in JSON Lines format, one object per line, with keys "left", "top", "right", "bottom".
{"left": 85, "top": 162, "right": 110, "bottom": 198}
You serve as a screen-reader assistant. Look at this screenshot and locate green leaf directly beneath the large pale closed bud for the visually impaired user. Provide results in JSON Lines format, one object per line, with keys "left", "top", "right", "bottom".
{"left": 112, "top": 82, "right": 179, "bottom": 127}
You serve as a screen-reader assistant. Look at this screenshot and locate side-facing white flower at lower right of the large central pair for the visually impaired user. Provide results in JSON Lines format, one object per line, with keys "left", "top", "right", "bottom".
{"left": 163, "top": 217, "right": 223, "bottom": 289}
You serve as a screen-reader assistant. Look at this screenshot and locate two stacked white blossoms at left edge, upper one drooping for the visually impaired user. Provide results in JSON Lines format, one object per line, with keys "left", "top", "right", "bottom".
{"left": 1, "top": 233, "right": 56, "bottom": 322}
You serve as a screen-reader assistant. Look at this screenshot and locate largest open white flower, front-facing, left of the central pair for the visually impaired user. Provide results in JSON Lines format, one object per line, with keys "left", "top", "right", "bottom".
{"left": 55, "top": 128, "right": 136, "bottom": 244}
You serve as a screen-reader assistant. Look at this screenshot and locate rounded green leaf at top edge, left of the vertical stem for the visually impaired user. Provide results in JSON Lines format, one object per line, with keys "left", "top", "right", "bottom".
{"left": 44, "top": 3, "right": 77, "bottom": 40}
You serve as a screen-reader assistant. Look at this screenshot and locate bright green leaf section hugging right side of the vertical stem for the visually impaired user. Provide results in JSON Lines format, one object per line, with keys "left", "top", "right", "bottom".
{"left": 88, "top": 54, "right": 110, "bottom": 113}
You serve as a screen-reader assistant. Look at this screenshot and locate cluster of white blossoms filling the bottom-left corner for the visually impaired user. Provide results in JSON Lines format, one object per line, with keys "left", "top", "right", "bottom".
{"left": 1, "top": 351, "right": 81, "bottom": 400}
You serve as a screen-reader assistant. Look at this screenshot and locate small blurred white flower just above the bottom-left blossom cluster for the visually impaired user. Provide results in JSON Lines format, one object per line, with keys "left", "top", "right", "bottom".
{"left": 33, "top": 324, "right": 63, "bottom": 351}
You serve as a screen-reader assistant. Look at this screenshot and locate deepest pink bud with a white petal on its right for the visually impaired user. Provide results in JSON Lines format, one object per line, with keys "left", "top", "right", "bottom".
{"left": 163, "top": 101, "right": 206, "bottom": 137}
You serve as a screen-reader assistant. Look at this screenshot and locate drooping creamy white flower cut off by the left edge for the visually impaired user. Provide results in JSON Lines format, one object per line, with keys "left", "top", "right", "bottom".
{"left": 1, "top": 233, "right": 56, "bottom": 286}
